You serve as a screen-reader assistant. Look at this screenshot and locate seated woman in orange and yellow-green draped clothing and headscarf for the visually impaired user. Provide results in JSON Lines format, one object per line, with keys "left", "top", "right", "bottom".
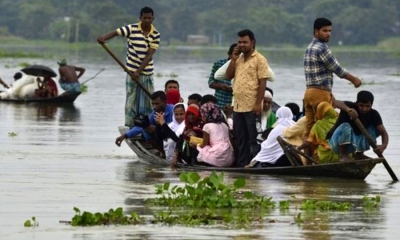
{"left": 298, "top": 102, "right": 339, "bottom": 163}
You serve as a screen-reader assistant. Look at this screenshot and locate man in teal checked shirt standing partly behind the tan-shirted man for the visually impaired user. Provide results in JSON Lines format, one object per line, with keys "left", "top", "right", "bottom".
{"left": 208, "top": 43, "right": 237, "bottom": 109}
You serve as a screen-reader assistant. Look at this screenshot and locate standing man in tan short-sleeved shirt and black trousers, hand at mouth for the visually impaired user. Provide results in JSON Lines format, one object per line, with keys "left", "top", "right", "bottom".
{"left": 226, "top": 29, "right": 270, "bottom": 167}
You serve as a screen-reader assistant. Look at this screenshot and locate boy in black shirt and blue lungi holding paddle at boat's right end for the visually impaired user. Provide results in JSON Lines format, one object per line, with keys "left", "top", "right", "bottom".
{"left": 327, "top": 91, "right": 389, "bottom": 161}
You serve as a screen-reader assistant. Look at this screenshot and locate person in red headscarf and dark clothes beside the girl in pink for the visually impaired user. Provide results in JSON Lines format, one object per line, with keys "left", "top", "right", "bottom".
{"left": 171, "top": 104, "right": 204, "bottom": 166}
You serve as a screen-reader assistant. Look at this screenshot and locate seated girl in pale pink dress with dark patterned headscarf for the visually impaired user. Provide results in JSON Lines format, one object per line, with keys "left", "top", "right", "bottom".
{"left": 191, "top": 102, "right": 234, "bottom": 167}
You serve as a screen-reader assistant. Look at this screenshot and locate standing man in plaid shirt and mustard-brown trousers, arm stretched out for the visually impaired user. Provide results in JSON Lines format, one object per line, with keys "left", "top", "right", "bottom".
{"left": 303, "top": 18, "right": 361, "bottom": 143}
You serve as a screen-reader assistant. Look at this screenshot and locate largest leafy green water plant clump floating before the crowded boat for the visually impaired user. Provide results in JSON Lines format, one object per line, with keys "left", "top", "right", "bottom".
{"left": 147, "top": 172, "right": 275, "bottom": 208}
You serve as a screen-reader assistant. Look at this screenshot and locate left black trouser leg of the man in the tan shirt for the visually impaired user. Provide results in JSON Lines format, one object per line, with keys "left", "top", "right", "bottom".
{"left": 233, "top": 112, "right": 250, "bottom": 167}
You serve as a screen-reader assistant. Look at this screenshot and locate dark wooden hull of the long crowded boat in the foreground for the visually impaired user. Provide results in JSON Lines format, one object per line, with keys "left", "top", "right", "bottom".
{"left": 119, "top": 127, "right": 384, "bottom": 180}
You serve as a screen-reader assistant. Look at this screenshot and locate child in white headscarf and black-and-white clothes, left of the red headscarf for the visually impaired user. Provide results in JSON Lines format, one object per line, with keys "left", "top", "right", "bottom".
{"left": 156, "top": 103, "right": 185, "bottom": 162}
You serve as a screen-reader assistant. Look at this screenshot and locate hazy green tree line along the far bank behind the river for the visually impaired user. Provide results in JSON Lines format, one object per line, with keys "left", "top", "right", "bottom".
{"left": 0, "top": 0, "right": 400, "bottom": 46}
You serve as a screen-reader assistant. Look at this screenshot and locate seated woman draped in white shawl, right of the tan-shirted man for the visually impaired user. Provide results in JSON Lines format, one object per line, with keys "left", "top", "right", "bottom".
{"left": 246, "top": 107, "right": 294, "bottom": 167}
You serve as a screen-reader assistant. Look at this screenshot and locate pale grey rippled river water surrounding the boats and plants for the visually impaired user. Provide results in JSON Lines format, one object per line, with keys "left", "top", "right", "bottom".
{"left": 0, "top": 53, "right": 400, "bottom": 240}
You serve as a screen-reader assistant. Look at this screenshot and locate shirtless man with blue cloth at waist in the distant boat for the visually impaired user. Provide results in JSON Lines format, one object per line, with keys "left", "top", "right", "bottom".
{"left": 56, "top": 59, "right": 85, "bottom": 94}
